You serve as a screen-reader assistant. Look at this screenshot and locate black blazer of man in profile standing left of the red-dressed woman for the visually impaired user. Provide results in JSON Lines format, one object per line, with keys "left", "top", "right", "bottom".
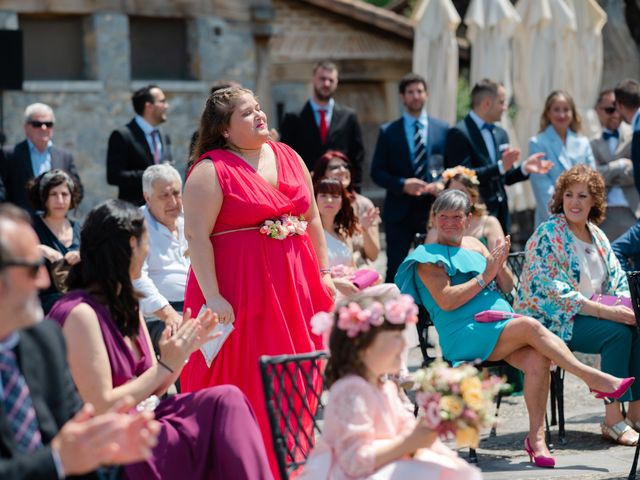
{"left": 107, "top": 119, "right": 173, "bottom": 206}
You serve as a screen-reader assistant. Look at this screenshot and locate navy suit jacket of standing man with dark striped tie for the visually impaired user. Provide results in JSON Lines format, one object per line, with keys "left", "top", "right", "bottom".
{"left": 371, "top": 117, "right": 449, "bottom": 222}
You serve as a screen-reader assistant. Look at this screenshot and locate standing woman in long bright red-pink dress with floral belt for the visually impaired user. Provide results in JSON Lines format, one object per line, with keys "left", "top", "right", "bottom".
{"left": 181, "top": 87, "right": 334, "bottom": 475}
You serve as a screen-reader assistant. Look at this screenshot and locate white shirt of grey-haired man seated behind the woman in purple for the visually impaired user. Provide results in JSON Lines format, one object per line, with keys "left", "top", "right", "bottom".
{"left": 133, "top": 205, "right": 191, "bottom": 316}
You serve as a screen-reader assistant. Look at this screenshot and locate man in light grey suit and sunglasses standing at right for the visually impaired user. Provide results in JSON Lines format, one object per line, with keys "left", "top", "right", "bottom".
{"left": 591, "top": 90, "right": 639, "bottom": 241}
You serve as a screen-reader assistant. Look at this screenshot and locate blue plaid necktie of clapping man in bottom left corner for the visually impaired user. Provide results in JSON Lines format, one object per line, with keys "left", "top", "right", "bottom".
{"left": 0, "top": 350, "right": 42, "bottom": 453}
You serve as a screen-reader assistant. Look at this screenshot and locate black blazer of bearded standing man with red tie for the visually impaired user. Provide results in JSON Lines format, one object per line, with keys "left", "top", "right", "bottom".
{"left": 280, "top": 101, "right": 364, "bottom": 187}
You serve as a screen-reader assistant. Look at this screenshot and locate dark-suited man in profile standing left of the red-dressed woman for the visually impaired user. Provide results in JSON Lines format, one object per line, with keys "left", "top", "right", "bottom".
{"left": 107, "top": 85, "right": 172, "bottom": 206}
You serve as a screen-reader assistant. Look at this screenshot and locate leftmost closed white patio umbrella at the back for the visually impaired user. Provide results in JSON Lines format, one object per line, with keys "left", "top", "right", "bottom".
{"left": 413, "top": 0, "right": 460, "bottom": 124}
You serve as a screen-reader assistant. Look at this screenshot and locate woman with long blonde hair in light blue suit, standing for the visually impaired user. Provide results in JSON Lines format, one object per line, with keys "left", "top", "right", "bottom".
{"left": 529, "top": 90, "right": 596, "bottom": 226}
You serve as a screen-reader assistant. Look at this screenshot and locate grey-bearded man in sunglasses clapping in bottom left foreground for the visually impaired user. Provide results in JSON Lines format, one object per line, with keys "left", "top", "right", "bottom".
{"left": 0, "top": 204, "right": 159, "bottom": 480}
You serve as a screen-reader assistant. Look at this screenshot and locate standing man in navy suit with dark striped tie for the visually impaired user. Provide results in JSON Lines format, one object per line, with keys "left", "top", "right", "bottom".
{"left": 371, "top": 73, "right": 449, "bottom": 283}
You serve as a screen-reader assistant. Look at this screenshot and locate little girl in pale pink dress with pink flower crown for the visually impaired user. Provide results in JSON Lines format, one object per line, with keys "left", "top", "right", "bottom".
{"left": 299, "top": 293, "right": 481, "bottom": 480}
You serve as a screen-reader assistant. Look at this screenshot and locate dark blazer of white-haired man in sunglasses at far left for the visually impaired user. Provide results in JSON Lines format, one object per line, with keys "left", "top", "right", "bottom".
{"left": 0, "top": 140, "right": 80, "bottom": 213}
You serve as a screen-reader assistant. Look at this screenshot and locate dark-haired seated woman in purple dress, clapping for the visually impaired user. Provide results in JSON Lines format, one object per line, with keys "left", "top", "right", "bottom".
{"left": 49, "top": 200, "right": 273, "bottom": 480}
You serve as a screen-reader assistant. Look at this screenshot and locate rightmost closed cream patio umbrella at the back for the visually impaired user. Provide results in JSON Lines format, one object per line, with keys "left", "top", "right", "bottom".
{"left": 565, "top": 0, "right": 607, "bottom": 137}
